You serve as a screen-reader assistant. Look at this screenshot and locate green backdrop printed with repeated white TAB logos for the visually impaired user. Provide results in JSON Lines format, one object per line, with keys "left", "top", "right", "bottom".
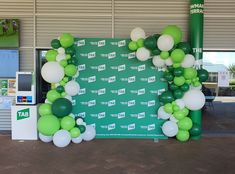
{"left": 73, "top": 38, "right": 167, "bottom": 139}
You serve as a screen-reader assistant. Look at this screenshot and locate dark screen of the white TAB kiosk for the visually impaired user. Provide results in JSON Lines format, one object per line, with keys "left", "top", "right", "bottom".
{"left": 18, "top": 74, "right": 32, "bottom": 91}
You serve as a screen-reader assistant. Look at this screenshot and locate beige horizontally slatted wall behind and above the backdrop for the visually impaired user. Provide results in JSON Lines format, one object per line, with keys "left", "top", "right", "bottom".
{"left": 0, "top": 0, "right": 235, "bottom": 130}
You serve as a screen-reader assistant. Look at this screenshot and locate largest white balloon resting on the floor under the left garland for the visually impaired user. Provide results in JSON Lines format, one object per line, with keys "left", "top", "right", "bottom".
{"left": 53, "top": 129, "right": 71, "bottom": 147}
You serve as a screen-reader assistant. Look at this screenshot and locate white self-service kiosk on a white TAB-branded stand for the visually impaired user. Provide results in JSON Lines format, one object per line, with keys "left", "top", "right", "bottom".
{"left": 11, "top": 72, "right": 38, "bottom": 140}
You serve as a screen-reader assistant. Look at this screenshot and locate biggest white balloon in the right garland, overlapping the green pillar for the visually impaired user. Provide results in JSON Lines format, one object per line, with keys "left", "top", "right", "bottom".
{"left": 183, "top": 89, "right": 206, "bottom": 111}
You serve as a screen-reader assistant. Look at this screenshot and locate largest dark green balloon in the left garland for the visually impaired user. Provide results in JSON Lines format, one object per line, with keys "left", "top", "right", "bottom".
{"left": 51, "top": 98, "right": 72, "bottom": 117}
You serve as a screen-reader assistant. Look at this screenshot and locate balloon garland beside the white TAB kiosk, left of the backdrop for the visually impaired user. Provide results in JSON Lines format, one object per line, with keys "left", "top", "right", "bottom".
{"left": 37, "top": 33, "right": 96, "bottom": 147}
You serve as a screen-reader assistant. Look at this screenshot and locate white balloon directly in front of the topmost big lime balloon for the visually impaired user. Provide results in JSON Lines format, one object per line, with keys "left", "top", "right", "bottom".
{"left": 157, "top": 34, "right": 174, "bottom": 51}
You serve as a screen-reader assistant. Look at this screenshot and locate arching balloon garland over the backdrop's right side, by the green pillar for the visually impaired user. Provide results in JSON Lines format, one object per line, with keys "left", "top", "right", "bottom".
{"left": 128, "top": 25, "right": 208, "bottom": 142}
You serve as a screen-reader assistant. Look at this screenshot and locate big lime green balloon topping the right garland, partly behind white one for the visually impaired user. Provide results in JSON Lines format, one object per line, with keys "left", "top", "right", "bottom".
{"left": 161, "top": 25, "right": 182, "bottom": 44}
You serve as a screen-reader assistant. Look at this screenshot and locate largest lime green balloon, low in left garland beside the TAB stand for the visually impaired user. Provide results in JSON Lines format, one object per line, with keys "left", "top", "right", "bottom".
{"left": 37, "top": 115, "right": 60, "bottom": 136}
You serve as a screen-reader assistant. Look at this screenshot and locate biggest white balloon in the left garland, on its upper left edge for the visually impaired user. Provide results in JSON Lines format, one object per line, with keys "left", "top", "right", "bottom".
{"left": 41, "top": 61, "right": 64, "bottom": 83}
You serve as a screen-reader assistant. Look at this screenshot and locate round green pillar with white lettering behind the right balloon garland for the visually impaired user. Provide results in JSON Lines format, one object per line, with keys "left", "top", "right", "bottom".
{"left": 189, "top": 0, "right": 204, "bottom": 140}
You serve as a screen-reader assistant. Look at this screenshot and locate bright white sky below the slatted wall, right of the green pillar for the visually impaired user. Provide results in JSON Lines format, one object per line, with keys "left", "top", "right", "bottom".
{"left": 203, "top": 52, "right": 235, "bottom": 67}
